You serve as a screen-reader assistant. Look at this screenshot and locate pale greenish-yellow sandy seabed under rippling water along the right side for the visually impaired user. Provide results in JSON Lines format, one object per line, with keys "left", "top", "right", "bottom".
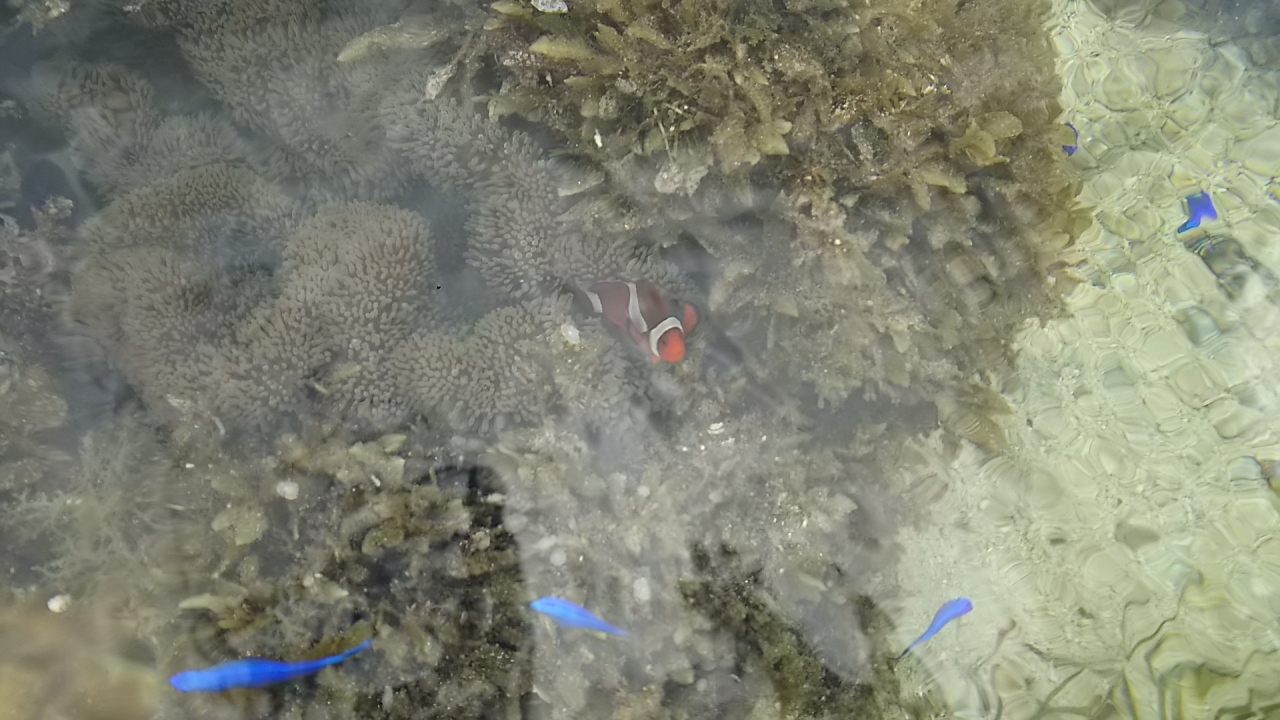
{"left": 895, "top": 0, "right": 1280, "bottom": 719}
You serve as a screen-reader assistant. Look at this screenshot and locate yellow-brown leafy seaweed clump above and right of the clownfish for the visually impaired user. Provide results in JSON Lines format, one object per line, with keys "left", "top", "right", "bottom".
{"left": 484, "top": 0, "right": 1088, "bottom": 415}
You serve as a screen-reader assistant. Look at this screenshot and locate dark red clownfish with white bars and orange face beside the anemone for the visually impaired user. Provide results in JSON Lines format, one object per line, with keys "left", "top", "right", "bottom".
{"left": 580, "top": 281, "right": 698, "bottom": 363}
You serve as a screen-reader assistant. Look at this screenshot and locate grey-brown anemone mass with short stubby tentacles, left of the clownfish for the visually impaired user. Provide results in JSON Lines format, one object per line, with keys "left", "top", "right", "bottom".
{"left": 32, "top": 8, "right": 678, "bottom": 440}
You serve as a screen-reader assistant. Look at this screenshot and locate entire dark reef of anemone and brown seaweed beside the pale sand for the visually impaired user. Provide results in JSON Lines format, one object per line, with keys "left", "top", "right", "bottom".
{"left": 0, "top": 0, "right": 1080, "bottom": 717}
